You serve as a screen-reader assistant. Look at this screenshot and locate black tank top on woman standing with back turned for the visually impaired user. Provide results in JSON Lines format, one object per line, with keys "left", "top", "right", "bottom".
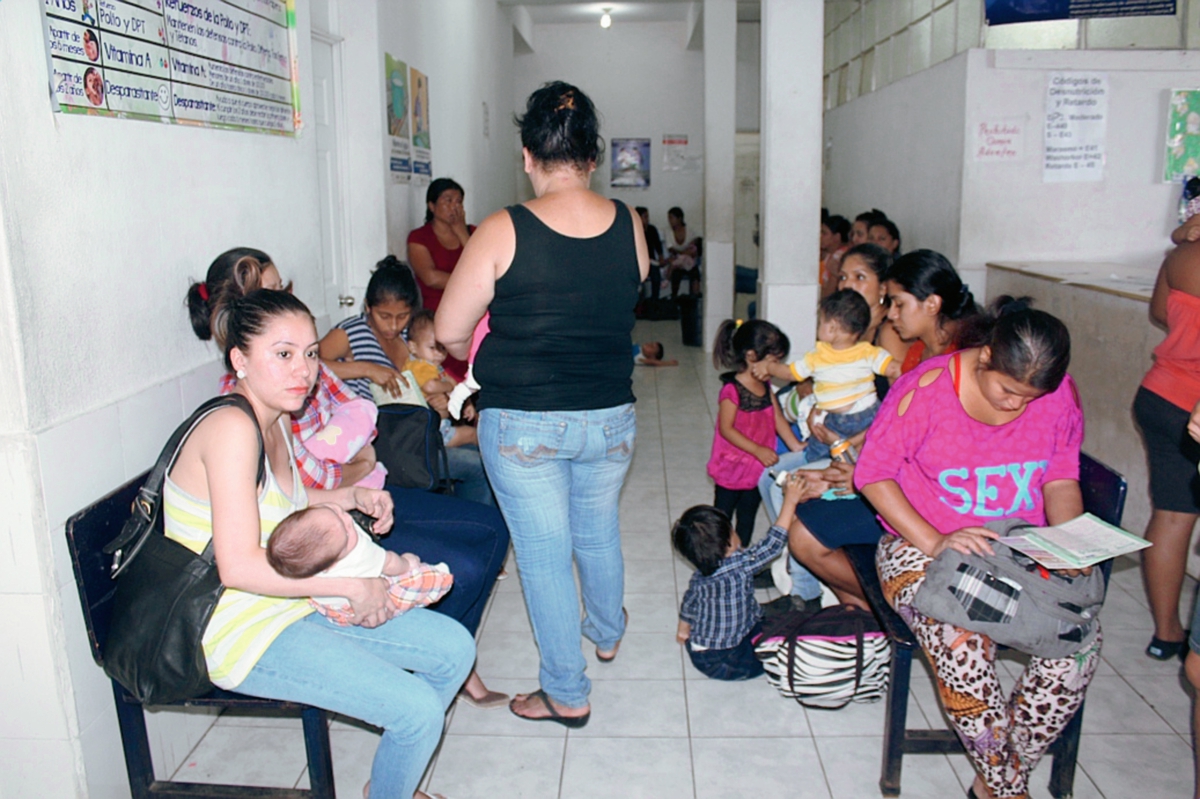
{"left": 474, "top": 200, "right": 641, "bottom": 410}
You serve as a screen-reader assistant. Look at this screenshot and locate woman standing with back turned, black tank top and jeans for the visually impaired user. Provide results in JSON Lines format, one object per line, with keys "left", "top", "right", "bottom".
{"left": 437, "top": 82, "right": 649, "bottom": 727}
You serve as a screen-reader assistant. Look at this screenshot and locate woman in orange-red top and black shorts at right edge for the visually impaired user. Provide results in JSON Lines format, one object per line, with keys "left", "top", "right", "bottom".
{"left": 1133, "top": 217, "right": 1200, "bottom": 660}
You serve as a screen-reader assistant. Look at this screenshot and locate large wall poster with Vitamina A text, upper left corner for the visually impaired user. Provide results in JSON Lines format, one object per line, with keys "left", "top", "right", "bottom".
{"left": 42, "top": 0, "right": 300, "bottom": 136}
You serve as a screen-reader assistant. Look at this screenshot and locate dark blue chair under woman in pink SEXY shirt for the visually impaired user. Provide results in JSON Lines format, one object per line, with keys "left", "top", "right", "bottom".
{"left": 844, "top": 452, "right": 1128, "bottom": 799}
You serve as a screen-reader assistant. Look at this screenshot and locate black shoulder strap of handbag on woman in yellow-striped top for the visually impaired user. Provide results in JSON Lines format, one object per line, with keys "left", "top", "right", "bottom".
{"left": 103, "top": 394, "right": 266, "bottom": 578}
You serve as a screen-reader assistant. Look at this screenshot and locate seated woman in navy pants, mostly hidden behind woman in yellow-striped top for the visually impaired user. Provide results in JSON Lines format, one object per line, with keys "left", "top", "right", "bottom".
{"left": 185, "top": 247, "right": 509, "bottom": 707}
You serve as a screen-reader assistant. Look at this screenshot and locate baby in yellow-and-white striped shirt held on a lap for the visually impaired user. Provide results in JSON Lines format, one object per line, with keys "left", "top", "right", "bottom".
{"left": 751, "top": 289, "right": 900, "bottom": 463}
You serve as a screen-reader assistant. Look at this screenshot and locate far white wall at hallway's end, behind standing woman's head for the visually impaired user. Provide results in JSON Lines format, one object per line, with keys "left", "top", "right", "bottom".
{"left": 513, "top": 22, "right": 700, "bottom": 240}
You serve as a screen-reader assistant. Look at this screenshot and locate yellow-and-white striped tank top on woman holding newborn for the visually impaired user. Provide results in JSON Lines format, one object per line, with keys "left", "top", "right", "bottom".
{"left": 162, "top": 419, "right": 312, "bottom": 691}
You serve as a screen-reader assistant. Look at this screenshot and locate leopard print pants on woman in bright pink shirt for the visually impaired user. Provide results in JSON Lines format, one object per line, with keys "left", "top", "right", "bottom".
{"left": 876, "top": 535, "right": 1100, "bottom": 798}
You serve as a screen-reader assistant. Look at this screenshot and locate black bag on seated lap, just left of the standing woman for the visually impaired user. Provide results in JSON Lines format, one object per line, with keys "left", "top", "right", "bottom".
{"left": 374, "top": 403, "right": 452, "bottom": 493}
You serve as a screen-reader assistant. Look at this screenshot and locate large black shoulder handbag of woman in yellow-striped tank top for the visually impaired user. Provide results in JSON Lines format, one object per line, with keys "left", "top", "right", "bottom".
{"left": 103, "top": 394, "right": 266, "bottom": 704}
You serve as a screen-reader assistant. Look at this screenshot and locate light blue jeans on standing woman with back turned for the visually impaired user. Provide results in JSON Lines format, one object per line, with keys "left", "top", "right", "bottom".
{"left": 479, "top": 404, "right": 637, "bottom": 708}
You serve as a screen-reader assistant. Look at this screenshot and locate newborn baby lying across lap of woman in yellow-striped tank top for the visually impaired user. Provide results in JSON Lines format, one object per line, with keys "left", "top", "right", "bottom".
{"left": 266, "top": 505, "right": 454, "bottom": 626}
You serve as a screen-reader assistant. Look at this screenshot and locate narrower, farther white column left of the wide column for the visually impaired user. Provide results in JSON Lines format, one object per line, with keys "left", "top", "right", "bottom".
{"left": 703, "top": 0, "right": 738, "bottom": 348}
